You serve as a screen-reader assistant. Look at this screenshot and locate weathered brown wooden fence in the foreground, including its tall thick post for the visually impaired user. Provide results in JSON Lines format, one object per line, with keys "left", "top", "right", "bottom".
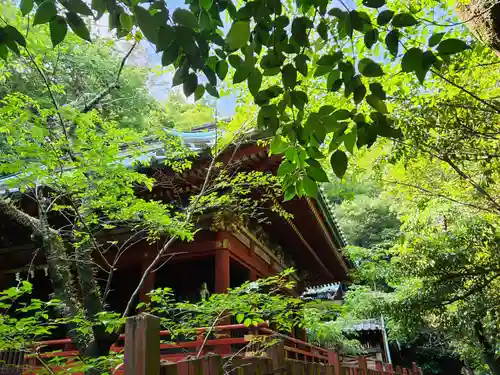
{"left": 123, "top": 314, "right": 422, "bottom": 375}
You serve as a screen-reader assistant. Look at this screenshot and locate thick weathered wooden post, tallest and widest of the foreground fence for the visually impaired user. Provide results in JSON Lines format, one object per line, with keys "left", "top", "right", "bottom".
{"left": 124, "top": 314, "right": 160, "bottom": 375}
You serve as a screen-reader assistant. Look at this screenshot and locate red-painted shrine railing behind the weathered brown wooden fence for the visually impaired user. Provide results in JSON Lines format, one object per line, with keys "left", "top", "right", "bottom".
{"left": 25, "top": 323, "right": 421, "bottom": 375}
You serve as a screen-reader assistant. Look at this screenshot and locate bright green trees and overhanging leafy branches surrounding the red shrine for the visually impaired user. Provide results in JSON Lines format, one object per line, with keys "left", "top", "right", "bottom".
{"left": 0, "top": 0, "right": 500, "bottom": 375}
